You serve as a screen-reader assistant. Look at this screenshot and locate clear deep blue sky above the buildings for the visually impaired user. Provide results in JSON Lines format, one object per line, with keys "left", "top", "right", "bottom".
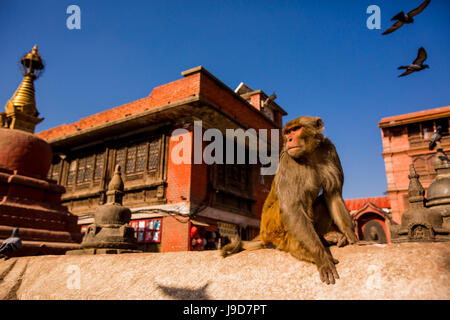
{"left": 0, "top": 0, "right": 450, "bottom": 198}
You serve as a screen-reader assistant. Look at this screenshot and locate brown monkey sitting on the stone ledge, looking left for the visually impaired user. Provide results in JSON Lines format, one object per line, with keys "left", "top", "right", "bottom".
{"left": 222, "top": 116, "right": 357, "bottom": 284}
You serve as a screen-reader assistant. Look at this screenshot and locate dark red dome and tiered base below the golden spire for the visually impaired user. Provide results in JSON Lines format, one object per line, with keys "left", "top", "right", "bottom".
{"left": 0, "top": 128, "right": 81, "bottom": 256}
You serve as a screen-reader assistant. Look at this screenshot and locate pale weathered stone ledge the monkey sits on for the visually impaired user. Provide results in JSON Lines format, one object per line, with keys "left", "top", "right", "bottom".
{"left": 0, "top": 243, "right": 450, "bottom": 300}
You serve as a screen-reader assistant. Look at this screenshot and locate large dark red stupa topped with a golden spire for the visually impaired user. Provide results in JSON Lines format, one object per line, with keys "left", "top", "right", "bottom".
{"left": 0, "top": 46, "right": 81, "bottom": 256}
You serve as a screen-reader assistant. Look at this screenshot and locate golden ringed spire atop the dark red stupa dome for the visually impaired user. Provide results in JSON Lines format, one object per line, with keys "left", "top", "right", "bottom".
{"left": 3, "top": 45, "right": 44, "bottom": 133}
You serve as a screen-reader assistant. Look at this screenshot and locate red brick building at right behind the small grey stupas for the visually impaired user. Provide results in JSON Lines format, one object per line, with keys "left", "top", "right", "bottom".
{"left": 378, "top": 106, "right": 450, "bottom": 223}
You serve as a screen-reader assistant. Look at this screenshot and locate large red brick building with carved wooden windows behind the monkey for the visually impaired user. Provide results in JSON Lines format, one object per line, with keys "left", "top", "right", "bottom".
{"left": 37, "top": 67, "right": 286, "bottom": 251}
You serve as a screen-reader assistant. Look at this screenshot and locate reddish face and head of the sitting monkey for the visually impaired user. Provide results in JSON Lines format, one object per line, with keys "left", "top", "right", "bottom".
{"left": 283, "top": 116, "right": 323, "bottom": 159}
